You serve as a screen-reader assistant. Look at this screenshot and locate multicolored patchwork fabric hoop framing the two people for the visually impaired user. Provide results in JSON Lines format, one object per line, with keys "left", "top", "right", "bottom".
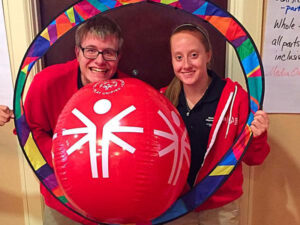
{"left": 14, "top": 0, "right": 264, "bottom": 224}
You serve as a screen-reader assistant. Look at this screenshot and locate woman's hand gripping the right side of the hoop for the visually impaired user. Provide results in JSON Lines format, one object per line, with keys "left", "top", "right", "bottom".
{"left": 250, "top": 110, "right": 269, "bottom": 137}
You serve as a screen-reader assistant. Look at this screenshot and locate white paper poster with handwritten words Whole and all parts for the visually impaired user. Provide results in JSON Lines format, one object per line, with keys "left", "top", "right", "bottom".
{"left": 262, "top": 0, "right": 300, "bottom": 113}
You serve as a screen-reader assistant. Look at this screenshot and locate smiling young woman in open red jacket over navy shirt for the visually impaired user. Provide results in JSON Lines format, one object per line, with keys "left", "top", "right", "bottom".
{"left": 162, "top": 24, "right": 270, "bottom": 225}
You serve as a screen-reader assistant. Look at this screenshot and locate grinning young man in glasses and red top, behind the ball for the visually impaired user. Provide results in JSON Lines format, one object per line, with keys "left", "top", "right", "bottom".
{"left": 25, "top": 16, "right": 127, "bottom": 225}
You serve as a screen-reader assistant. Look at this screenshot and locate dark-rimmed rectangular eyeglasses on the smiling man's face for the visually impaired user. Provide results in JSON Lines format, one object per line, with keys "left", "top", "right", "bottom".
{"left": 80, "top": 46, "right": 119, "bottom": 61}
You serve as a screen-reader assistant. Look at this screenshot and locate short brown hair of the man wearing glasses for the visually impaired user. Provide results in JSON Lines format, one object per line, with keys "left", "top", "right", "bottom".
{"left": 75, "top": 16, "right": 123, "bottom": 50}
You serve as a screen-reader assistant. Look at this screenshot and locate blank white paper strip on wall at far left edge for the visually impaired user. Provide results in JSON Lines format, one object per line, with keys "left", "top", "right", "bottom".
{"left": 0, "top": 0, "right": 13, "bottom": 109}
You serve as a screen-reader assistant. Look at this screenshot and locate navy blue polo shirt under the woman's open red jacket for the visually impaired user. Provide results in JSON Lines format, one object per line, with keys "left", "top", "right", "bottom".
{"left": 177, "top": 71, "right": 226, "bottom": 187}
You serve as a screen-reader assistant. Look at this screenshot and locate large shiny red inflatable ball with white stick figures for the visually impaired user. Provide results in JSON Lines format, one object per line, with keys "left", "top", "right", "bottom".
{"left": 52, "top": 78, "right": 190, "bottom": 224}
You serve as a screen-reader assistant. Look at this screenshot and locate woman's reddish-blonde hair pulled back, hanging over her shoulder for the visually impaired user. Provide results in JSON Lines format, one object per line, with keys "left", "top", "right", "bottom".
{"left": 164, "top": 24, "right": 212, "bottom": 107}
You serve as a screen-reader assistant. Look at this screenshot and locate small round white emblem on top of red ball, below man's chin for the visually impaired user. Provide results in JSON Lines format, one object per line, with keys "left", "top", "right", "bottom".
{"left": 93, "top": 80, "right": 125, "bottom": 95}
